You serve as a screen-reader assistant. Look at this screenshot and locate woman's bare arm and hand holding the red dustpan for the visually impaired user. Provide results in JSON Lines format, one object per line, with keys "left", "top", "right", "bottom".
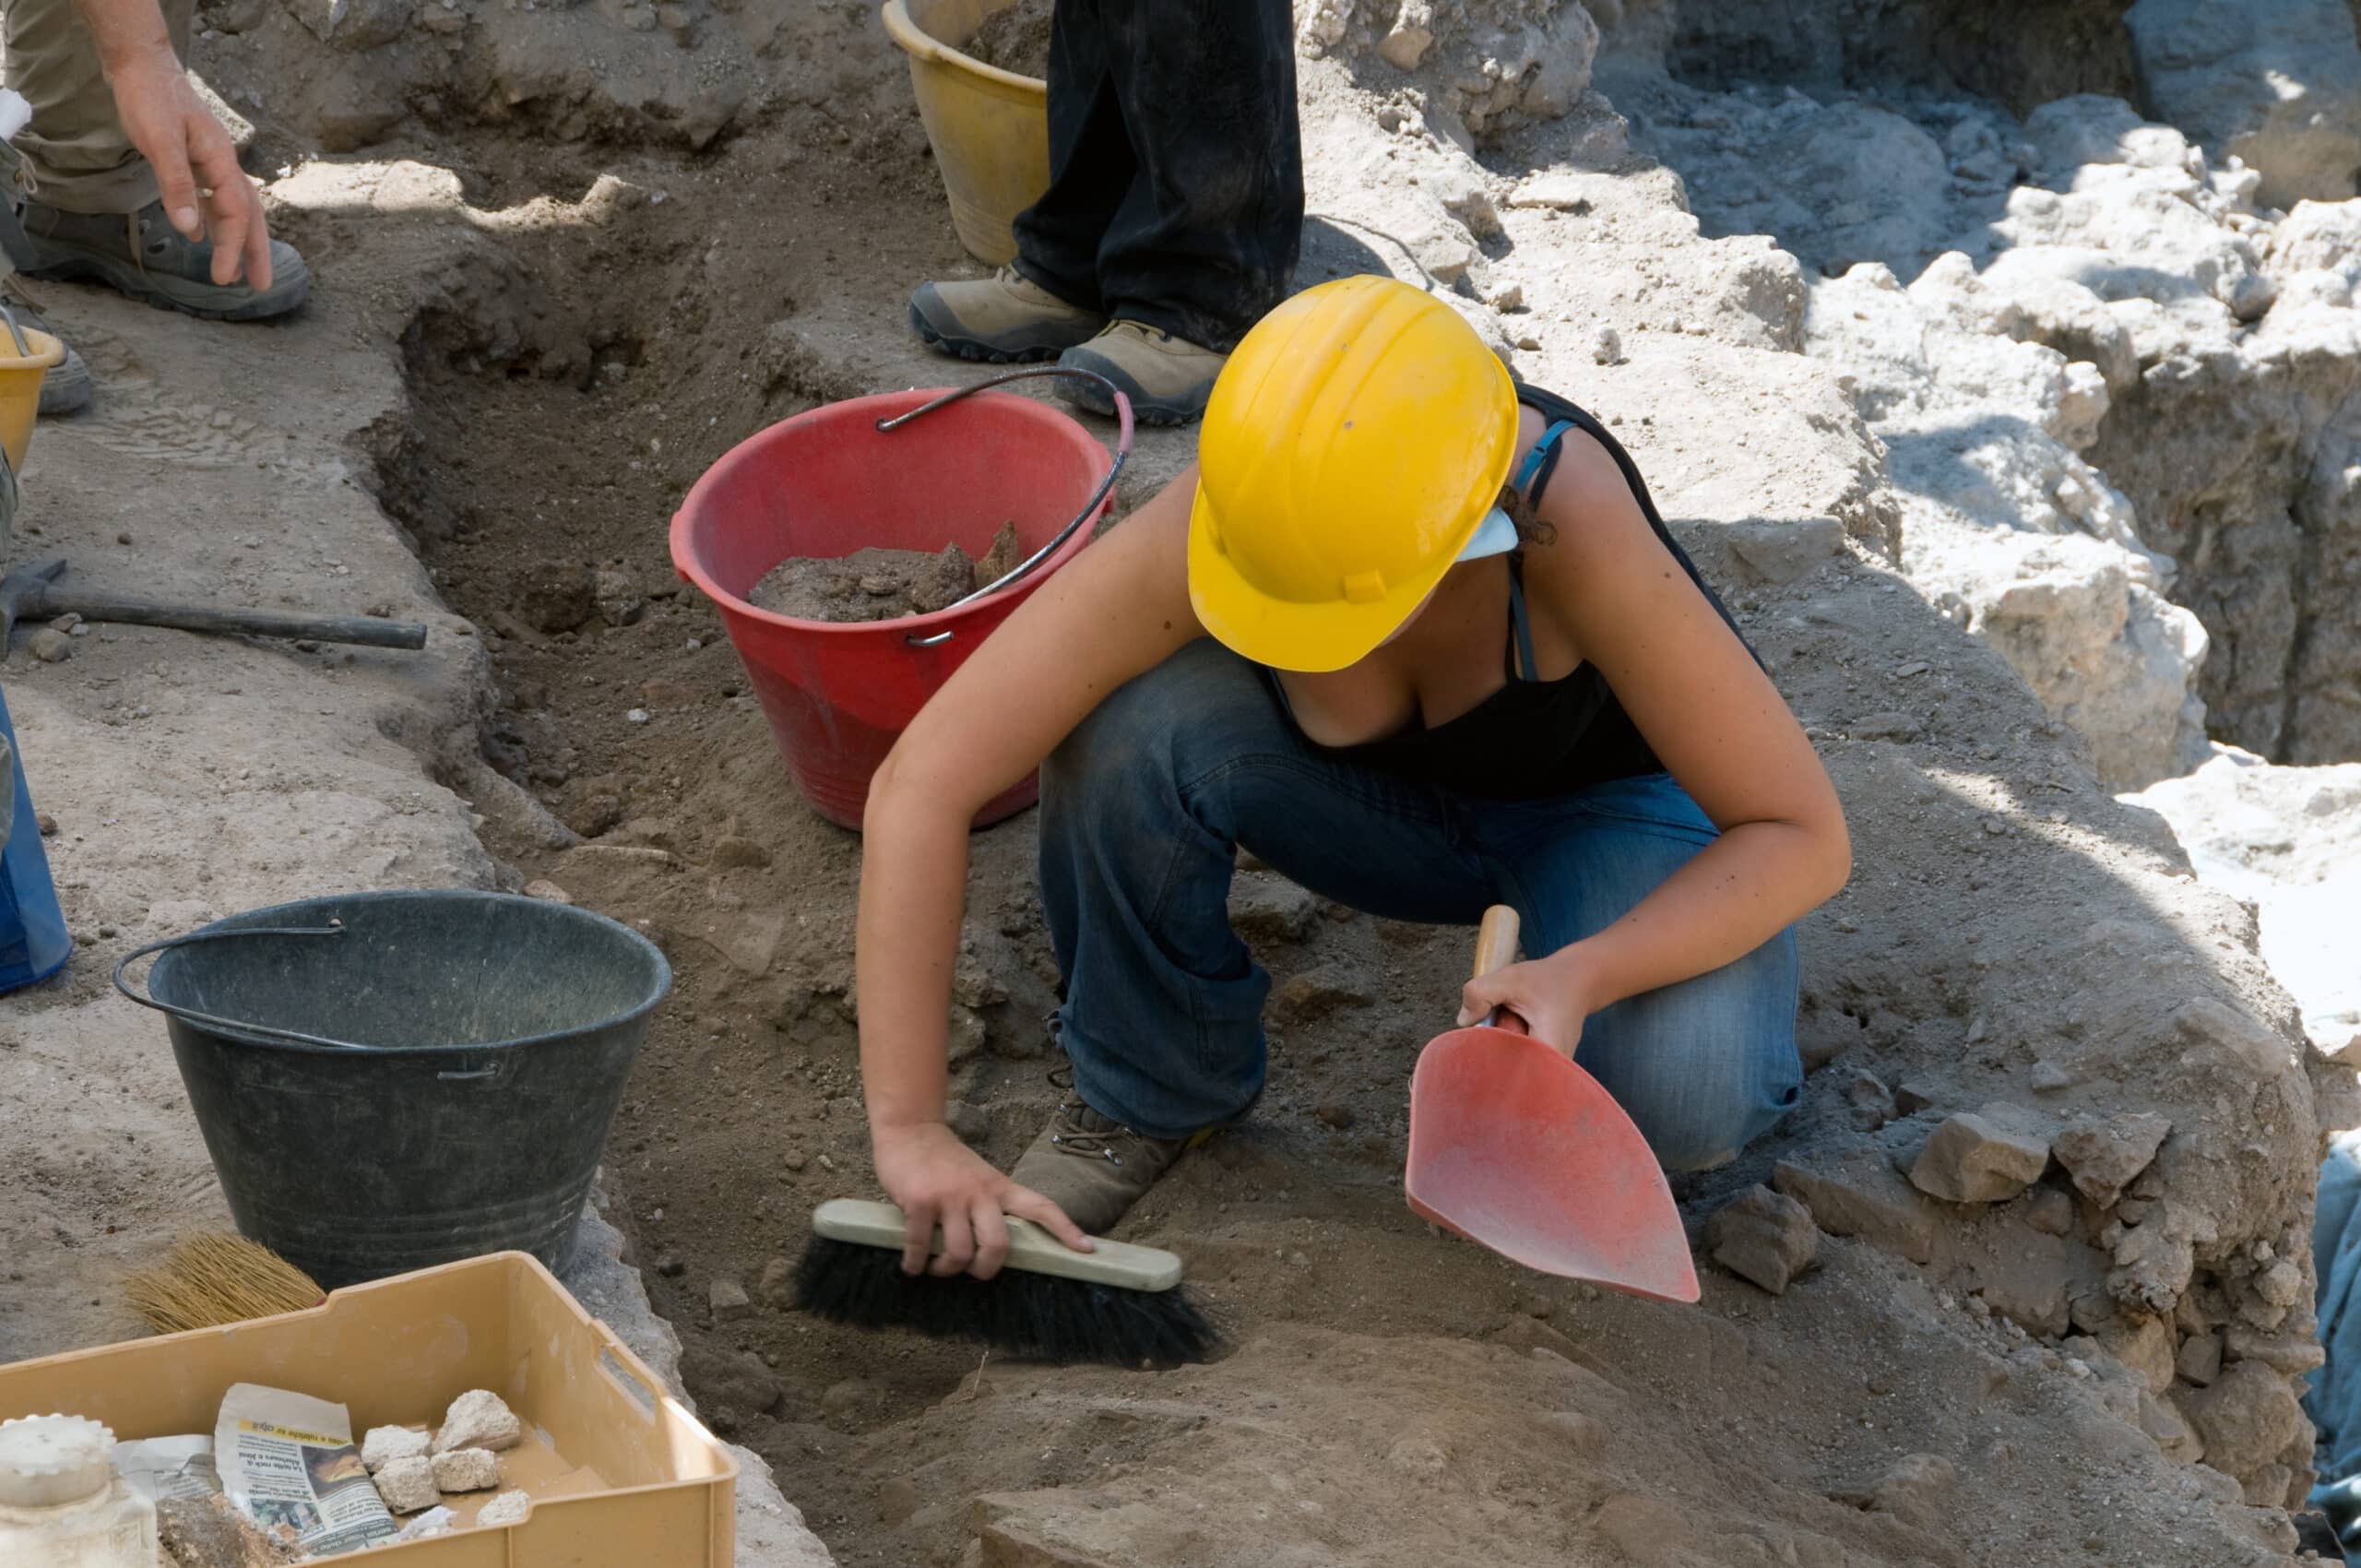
{"left": 1466, "top": 437, "right": 1851, "bottom": 1049}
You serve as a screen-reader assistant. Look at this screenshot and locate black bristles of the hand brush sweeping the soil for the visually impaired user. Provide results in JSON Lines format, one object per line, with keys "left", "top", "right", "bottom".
{"left": 796, "top": 1235, "right": 1223, "bottom": 1367}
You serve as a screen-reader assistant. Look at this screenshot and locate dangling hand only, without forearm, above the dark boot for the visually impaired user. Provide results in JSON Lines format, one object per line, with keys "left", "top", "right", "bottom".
{"left": 106, "top": 50, "right": 271, "bottom": 288}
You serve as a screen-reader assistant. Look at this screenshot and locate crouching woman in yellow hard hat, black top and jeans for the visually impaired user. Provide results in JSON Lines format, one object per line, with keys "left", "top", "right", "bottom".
{"left": 857, "top": 279, "right": 1848, "bottom": 1277}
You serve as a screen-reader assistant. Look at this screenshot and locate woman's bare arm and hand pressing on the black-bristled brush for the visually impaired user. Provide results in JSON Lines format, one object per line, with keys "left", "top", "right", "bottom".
{"left": 855, "top": 468, "right": 1202, "bottom": 1277}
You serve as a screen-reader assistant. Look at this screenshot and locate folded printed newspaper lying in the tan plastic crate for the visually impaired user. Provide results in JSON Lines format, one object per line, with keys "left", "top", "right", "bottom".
{"left": 212, "top": 1384, "right": 395, "bottom": 1556}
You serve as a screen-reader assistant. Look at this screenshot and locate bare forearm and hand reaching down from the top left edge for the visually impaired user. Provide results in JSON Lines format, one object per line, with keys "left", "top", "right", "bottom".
{"left": 76, "top": 0, "right": 271, "bottom": 288}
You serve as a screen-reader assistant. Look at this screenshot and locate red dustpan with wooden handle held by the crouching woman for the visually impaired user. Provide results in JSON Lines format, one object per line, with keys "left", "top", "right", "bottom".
{"left": 1403, "top": 907, "right": 1698, "bottom": 1301}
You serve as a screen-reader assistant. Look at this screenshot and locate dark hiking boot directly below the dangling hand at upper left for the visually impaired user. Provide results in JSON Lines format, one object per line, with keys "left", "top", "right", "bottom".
{"left": 18, "top": 201, "right": 312, "bottom": 321}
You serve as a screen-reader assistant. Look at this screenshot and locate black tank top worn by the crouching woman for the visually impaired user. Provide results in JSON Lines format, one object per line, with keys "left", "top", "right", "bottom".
{"left": 1265, "top": 387, "right": 1752, "bottom": 801}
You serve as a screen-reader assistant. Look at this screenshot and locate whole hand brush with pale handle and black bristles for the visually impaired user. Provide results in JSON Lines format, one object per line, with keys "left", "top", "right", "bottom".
{"left": 796, "top": 1197, "right": 1223, "bottom": 1367}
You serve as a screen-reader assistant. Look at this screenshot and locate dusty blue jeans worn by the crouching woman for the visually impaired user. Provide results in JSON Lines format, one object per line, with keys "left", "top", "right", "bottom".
{"left": 1041, "top": 640, "right": 1804, "bottom": 1171}
